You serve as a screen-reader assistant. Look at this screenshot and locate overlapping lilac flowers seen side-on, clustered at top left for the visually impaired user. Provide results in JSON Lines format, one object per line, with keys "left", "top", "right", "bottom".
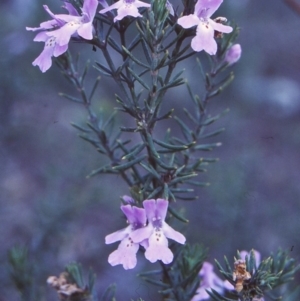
{"left": 26, "top": 0, "right": 98, "bottom": 72}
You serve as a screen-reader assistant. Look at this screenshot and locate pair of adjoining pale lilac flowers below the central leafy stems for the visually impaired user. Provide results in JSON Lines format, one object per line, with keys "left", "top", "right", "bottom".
{"left": 105, "top": 199, "right": 185, "bottom": 270}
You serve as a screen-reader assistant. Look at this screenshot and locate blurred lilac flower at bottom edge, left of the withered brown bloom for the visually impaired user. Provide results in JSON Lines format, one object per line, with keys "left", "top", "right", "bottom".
{"left": 191, "top": 261, "right": 224, "bottom": 301}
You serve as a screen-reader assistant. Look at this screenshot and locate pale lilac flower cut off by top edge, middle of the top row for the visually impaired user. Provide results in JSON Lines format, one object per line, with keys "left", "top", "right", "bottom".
{"left": 99, "top": 0, "right": 151, "bottom": 22}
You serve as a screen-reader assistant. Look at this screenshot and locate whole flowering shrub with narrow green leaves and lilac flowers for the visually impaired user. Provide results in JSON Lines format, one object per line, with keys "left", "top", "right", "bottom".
{"left": 10, "top": 0, "right": 299, "bottom": 301}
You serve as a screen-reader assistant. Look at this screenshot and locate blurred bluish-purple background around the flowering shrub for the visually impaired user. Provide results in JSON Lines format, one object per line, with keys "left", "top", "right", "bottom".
{"left": 0, "top": 0, "right": 300, "bottom": 301}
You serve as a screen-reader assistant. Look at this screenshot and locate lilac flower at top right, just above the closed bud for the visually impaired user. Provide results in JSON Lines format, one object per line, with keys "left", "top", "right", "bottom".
{"left": 178, "top": 0, "right": 232, "bottom": 55}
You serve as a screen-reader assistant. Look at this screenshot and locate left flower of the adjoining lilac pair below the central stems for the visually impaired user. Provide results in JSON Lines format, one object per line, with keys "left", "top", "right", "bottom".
{"left": 105, "top": 205, "right": 146, "bottom": 270}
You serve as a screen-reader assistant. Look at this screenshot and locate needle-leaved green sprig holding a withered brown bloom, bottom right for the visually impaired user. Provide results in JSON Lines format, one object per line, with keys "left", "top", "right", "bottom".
{"left": 211, "top": 250, "right": 300, "bottom": 301}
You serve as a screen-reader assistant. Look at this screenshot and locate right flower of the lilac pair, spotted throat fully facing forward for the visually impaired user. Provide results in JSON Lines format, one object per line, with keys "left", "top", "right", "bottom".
{"left": 131, "top": 199, "right": 185, "bottom": 264}
